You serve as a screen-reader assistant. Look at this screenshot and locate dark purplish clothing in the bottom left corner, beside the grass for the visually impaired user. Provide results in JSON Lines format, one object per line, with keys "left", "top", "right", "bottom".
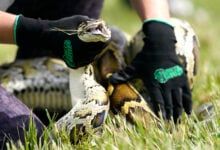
{"left": 0, "top": 86, "right": 44, "bottom": 149}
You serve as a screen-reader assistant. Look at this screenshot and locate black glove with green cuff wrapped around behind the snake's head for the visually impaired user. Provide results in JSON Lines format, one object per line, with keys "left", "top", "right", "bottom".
{"left": 14, "top": 15, "right": 105, "bottom": 68}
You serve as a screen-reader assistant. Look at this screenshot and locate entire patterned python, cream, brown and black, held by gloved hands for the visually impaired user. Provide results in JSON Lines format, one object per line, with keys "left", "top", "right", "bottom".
{"left": 0, "top": 19, "right": 199, "bottom": 141}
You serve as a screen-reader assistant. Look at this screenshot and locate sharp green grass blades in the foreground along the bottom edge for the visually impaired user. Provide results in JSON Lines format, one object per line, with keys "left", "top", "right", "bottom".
{"left": 5, "top": 111, "right": 220, "bottom": 150}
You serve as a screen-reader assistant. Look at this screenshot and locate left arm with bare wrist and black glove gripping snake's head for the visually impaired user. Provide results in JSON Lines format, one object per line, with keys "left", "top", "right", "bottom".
{"left": 0, "top": 11, "right": 110, "bottom": 68}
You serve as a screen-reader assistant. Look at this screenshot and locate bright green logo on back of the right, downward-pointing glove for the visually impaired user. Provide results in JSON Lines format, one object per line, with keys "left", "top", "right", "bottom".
{"left": 154, "top": 65, "right": 183, "bottom": 83}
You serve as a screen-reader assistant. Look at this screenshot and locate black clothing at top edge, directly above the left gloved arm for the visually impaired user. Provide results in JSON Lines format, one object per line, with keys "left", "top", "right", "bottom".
{"left": 7, "top": 0, "right": 103, "bottom": 20}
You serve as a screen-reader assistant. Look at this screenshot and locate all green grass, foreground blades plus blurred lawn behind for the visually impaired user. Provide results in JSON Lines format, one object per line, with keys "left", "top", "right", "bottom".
{"left": 0, "top": 0, "right": 220, "bottom": 150}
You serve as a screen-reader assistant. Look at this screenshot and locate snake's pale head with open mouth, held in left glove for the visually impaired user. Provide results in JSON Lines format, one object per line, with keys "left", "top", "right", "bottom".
{"left": 77, "top": 20, "right": 111, "bottom": 42}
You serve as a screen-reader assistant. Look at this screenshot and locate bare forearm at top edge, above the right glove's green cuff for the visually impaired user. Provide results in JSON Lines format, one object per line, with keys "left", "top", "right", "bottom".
{"left": 130, "top": 0, "right": 170, "bottom": 21}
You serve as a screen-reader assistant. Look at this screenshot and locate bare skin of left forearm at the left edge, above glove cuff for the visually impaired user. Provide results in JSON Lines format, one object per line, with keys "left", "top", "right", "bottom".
{"left": 0, "top": 11, "right": 16, "bottom": 44}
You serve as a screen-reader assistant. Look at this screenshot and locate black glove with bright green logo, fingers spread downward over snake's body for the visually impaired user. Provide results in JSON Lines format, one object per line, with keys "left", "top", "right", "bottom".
{"left": 110, "top": 20, "right": 192, "bottom": 122}
